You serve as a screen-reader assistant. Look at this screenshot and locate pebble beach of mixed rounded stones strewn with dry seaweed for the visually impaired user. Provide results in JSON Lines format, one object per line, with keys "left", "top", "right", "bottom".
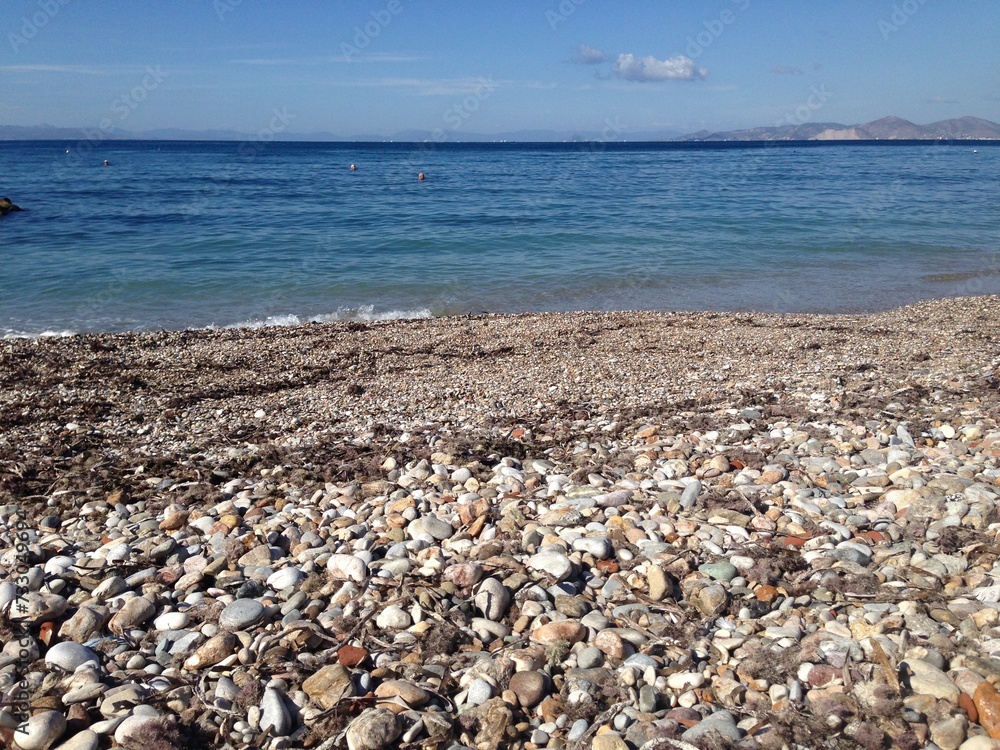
{"left": 0, "top": 297, "right": 1000, "bottom": 750}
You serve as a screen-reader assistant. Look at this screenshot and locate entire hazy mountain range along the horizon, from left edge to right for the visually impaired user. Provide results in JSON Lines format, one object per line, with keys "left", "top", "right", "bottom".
{"left": 0, "top": 117, "right": 1000, "bottom": 143}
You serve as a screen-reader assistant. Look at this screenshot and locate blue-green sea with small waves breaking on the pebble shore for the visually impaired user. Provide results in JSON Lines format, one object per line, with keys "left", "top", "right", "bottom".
{"left": 0, "top": 141, "right": 1000, "bottom": 338}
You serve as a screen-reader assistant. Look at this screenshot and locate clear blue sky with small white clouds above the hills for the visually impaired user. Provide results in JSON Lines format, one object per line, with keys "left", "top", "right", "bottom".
{"left": 0, "top": 0, "right": 1000, "bottom": 139}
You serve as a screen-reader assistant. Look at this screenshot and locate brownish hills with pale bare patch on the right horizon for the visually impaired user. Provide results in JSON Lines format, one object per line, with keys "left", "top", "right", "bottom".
{"left": 676, "top": 117, "right": 1000, "bottom": 141}
